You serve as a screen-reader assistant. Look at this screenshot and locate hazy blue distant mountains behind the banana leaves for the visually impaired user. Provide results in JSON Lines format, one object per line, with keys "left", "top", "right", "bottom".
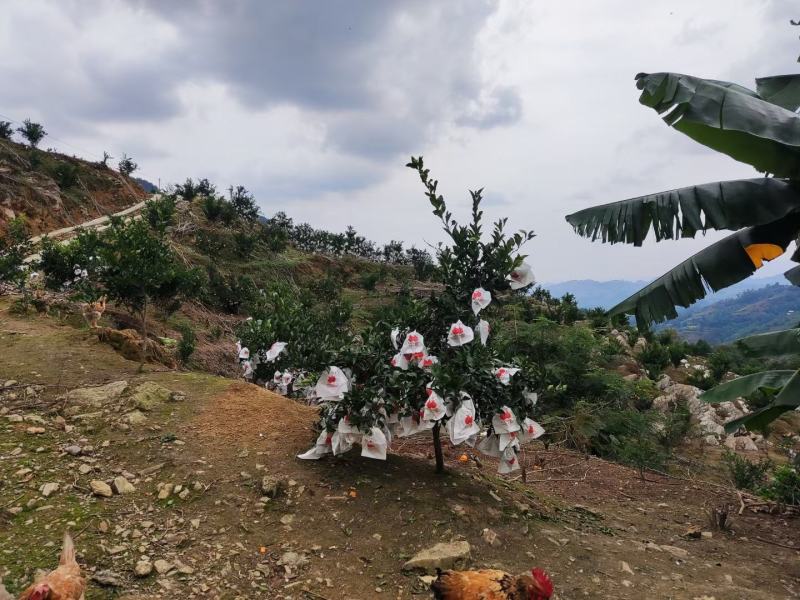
{"left": 542, "top": 275, "right": 800, "bottom": 343}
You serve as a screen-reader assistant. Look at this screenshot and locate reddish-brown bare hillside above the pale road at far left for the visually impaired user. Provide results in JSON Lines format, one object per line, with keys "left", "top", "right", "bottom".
{"left": 0, "top": 140, "right": 147, "bottom": 235}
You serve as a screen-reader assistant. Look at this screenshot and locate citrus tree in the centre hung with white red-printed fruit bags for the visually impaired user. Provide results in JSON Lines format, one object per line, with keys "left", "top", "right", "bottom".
{"left": 300, "top": 157, "right": 543, "bottom": 473}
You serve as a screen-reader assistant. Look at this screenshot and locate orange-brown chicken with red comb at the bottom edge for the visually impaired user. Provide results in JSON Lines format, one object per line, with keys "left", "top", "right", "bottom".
{"left": 431, "top": 569, "right": 553, "bottom": 600}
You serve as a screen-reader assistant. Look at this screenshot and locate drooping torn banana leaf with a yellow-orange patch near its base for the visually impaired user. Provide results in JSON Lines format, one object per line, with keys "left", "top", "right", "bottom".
{"left": 609, "top": 213, "right": 800, "bottom": 327}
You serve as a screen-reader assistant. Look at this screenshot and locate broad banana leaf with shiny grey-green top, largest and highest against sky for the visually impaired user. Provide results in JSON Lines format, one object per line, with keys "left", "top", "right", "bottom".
{"left": 636, "top": 73, "right": 800, "bottom": 178}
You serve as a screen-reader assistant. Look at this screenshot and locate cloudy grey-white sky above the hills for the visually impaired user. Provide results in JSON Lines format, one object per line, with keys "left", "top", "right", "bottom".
{"left": 0, "top": 0, "right": 800, "bottom": 281}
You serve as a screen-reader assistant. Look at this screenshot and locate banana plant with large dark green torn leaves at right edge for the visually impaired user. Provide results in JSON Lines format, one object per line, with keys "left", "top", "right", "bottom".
{"left": 567, "top": 73, "right": 800, "bottom": 429}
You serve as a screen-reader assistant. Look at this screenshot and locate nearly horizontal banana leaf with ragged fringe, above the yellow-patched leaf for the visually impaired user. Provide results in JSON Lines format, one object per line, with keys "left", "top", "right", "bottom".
{"left": 567, "top": 177, "right": 800, "bottom": 246}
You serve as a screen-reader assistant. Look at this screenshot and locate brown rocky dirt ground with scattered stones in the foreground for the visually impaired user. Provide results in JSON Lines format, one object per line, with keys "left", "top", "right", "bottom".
{"left": 0, "top": 302, "right": 800, "bottom": 600}
